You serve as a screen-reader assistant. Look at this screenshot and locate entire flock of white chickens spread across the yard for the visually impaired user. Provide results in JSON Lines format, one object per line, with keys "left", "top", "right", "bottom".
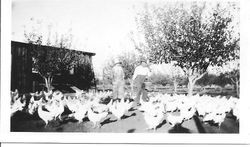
{"left": 11, "top": 91, "right": 239, "bottom": 130}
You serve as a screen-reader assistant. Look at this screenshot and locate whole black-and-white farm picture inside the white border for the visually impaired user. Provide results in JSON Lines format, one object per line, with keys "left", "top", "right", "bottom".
{"left": 1, "top": 0, "right": 249, "bottom": 145}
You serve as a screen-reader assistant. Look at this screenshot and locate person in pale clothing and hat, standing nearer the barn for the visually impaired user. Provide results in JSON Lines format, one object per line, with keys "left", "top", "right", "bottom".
{"left": 112, "top": 59, "right": 125, "bottom": 100}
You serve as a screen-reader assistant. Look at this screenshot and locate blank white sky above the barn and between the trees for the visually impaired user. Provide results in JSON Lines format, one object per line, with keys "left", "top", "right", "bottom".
{"left": 11, "top": 0, "right": 240, "bottom": 77}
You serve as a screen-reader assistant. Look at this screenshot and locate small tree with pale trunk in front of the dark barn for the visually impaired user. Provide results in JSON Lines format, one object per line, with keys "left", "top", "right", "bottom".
{"left": 24, "top": 19, "right": 77, "bottom": 91}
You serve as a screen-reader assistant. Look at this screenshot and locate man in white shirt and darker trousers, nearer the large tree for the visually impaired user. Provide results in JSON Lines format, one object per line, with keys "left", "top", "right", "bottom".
{"left": 132, "top": 60, "right": 150, "bottom": 106}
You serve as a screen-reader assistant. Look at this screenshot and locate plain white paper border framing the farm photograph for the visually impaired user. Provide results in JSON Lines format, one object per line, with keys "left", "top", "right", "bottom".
{"left": 0, "top": 0, "right": 250, "bottom": 144}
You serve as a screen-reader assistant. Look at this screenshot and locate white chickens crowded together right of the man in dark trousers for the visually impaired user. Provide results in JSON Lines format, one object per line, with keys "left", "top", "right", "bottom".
{"left": 139, "top": 93, "right": 239, "bottom": 130}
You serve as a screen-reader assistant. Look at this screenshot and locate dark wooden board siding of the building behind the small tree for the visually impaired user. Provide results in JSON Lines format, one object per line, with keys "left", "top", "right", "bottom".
{"left": 11, "top": 41, "right": 95, "bottom": 93}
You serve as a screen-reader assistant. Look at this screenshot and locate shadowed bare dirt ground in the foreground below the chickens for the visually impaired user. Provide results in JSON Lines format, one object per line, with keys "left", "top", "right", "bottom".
{"left": 11, "top": 107, "right": 239, "bottom": 133}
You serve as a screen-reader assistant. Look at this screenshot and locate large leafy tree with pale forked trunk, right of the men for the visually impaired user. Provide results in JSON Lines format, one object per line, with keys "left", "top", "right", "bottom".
{"left": 135, "top": 2, "right": 239, "bottom": 96}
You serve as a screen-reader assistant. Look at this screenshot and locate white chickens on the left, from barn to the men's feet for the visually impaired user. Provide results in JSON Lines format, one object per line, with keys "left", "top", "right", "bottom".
{"left": 11, "top": 91, "right": 133, "bottom": 127}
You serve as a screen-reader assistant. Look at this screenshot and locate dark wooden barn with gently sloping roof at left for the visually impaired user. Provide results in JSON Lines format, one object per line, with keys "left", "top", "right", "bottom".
{"left": 11, "top": 41, "right": 95, "bottom": 93}
